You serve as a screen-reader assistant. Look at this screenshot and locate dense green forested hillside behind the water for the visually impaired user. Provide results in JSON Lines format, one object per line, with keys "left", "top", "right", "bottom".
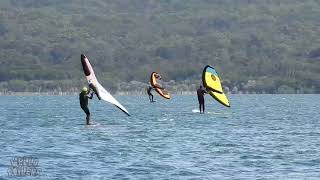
{"left": 0, "top": 0, "right": 320, "bottom": 93}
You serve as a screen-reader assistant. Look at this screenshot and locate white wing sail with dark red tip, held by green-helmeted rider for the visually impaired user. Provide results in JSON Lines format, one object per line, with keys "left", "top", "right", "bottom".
{"left": 81, "top": 54, "right": 130, "bottom": 116}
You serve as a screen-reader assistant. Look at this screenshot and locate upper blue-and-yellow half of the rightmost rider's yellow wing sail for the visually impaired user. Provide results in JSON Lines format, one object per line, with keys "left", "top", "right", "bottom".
{"left": 202, "top": 66, "right": 223, "bottom": 93}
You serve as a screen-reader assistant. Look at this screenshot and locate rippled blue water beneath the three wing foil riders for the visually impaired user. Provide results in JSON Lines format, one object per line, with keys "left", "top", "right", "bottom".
{"left": 0, "top": 95, "right": 320, "bottom": 179}
